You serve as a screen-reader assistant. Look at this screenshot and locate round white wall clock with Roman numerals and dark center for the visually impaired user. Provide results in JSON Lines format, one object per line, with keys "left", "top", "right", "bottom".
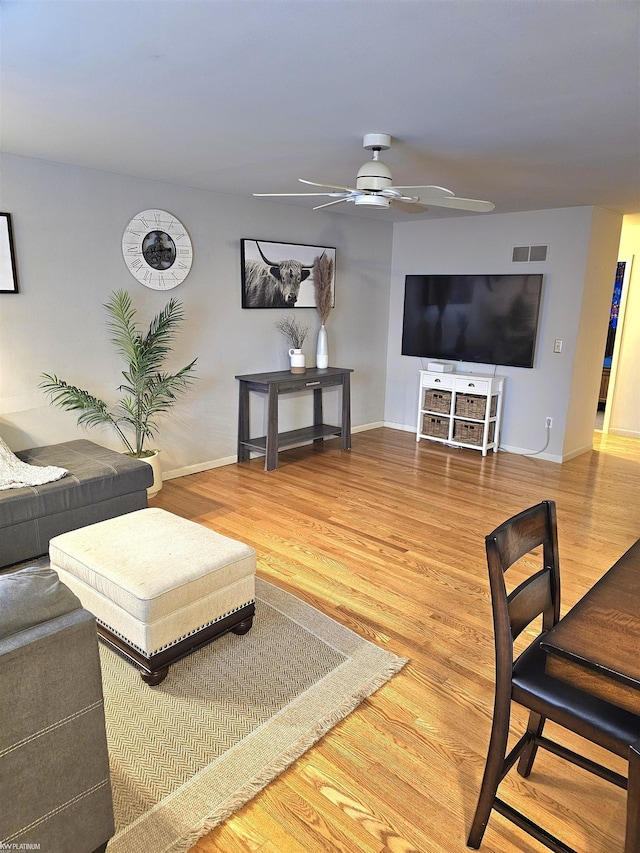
{"left": 122, "top": 210, "right": 193, "bottom": 290}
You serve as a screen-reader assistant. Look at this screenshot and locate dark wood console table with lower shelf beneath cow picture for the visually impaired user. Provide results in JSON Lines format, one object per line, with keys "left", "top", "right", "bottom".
{"left": 236, "top": 367, "right": 353, "bottom": 471}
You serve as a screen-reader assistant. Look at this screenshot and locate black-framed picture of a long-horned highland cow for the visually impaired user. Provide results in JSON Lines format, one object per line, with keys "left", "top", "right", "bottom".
{"left": 240, "top": 239, "right": 336, "bottom": 308}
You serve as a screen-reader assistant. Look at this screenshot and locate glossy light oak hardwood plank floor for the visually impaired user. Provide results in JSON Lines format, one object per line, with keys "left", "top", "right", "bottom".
{"left": 151, "top": 428, "right": 640, "bottom": 853}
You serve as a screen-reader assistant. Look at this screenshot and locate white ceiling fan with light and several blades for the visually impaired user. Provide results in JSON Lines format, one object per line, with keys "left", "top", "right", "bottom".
{"left": 253, "top": 133, "right": 495, "bottom": 213}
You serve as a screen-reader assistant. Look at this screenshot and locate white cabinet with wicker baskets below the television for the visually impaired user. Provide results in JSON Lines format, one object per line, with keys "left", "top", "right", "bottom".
{"left": 416, "top": 370, "right": 506, "bottom": 456}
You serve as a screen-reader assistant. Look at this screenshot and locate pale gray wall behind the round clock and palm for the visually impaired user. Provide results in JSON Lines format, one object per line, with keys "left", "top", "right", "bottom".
{"left": 0, "top": 155, "right": 393, "bottom": 475}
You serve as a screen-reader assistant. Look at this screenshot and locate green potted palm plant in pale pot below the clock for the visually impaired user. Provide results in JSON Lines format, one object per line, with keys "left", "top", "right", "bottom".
{"left": 40, "top": 290, "right": 197, "bottom": 497}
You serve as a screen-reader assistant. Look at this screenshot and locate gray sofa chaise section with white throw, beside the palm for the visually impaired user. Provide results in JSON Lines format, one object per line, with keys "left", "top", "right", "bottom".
{"left": 0, "top": 439, "right": 153, "bottom": 567}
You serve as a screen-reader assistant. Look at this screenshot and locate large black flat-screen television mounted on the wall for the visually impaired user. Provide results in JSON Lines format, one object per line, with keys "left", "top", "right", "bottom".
{"left": 402, "top": 274, "right": 542, "bottom": 367}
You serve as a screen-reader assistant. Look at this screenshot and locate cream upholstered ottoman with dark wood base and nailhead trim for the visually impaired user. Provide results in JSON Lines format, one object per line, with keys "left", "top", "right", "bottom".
{"left": 49, "top": 508, "right": 256, "bottom": 685}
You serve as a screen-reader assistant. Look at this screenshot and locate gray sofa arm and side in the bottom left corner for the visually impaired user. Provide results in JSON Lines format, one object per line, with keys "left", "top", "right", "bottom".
{"left": 0, "top": 567, "right": 114, "bottom": 853}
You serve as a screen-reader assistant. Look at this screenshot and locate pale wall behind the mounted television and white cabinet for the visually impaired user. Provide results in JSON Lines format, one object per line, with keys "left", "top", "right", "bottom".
{"left": 385, "top": 207, "right": 621, "bottom": 462}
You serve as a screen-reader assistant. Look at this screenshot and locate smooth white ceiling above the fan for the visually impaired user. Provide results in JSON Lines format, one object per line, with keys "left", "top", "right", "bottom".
{"left": 0, "top": 0, "right": 640, "bottom": 221}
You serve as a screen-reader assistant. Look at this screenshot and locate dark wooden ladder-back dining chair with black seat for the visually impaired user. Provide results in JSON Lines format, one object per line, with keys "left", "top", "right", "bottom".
{"left": 467, "top": 501, "right": 640, "bottom": 853}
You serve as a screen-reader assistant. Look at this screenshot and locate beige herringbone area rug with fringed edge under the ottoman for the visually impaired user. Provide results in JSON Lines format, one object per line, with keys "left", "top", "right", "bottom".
{"left": 100, "top": 579, "right": 406, "bottom": 853}
